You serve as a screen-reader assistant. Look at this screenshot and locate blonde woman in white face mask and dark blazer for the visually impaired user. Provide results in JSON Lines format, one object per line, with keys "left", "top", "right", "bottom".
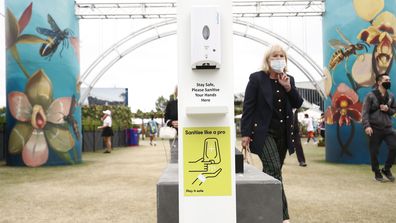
{"left": 241, "top": 45, "right": 303, "bottom": 223}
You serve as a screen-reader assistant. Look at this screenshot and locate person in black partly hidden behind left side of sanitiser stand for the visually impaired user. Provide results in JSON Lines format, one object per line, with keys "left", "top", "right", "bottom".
{"left": 164, "top": 86, "right": 179, "bottom": 163}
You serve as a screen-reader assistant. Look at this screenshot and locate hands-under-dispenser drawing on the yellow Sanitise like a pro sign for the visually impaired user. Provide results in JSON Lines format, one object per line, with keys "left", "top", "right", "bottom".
{"left": 189, "top": 138, "right": 222, "bottom": 185}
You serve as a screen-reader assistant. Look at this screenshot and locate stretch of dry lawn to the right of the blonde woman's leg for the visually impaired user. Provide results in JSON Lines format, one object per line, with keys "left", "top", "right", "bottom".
{"left": 256, "top": 141, "right": 396, "bottom": 223}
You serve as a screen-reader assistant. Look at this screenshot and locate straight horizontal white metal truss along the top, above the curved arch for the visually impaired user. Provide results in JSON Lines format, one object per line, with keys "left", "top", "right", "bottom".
{"left": 75, "top": 0, "right": 325, "bottom": 19}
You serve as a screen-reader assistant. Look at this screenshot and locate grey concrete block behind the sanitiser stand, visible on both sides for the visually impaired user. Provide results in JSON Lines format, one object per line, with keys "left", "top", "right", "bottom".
{"left": 157, "top": 164, "right": 282, "bottom": 223}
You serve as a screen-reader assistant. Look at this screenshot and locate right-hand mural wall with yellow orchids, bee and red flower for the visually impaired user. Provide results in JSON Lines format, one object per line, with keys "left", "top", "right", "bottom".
{"left": 323, "top": 0, "right": 396, "bottom": 163}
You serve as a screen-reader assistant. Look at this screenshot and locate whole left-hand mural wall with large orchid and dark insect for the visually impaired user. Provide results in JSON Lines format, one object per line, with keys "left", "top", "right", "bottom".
{"left": 5, "top": 0, "right": 81, "bottom": 167}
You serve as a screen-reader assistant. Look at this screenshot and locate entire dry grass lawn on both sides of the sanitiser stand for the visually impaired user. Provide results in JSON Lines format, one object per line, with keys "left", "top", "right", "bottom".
{"left": 0, "top": 141, "right": 396, "bottom": 223}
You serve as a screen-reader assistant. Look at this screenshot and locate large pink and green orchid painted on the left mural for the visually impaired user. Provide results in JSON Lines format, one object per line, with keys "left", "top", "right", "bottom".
{"left": 8, "top": 70, "right": 74, "bottom": 167}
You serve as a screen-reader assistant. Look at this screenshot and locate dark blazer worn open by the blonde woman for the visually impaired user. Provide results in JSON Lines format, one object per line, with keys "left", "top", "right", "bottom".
{"left": 241, "top": 71, "right": 303, "bottom": 154}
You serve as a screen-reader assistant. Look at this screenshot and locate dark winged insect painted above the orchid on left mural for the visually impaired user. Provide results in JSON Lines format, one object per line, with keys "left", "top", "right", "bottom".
{"left": 36, "top": 14, "right": 73, "bottom": 60}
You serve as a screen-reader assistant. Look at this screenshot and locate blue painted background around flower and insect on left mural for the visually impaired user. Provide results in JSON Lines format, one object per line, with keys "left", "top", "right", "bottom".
{"left": 5, "top": 0, "right": 81, "bottom": 166}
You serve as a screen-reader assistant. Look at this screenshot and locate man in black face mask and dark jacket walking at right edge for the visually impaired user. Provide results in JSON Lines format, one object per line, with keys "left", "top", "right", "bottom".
{"left": 362, "top": 74, "right": 396, "bottom": 182}
